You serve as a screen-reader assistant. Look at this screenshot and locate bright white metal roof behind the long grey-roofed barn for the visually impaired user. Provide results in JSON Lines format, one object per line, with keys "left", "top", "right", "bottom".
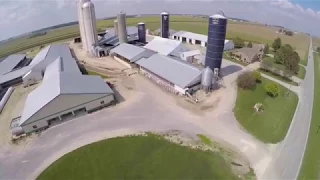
{"left": 144, "top": 37, "right": 182, "bottom": 56}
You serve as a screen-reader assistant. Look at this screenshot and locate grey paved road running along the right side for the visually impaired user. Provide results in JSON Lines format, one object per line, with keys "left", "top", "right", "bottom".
{"left": 264, "top": 40, "right": 314, "bottom": 179}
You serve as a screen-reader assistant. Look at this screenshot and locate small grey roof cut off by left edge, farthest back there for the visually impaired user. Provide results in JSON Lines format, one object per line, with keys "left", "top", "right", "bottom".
{"left": 0, "top": 54, "right": 26, "bottom": 74}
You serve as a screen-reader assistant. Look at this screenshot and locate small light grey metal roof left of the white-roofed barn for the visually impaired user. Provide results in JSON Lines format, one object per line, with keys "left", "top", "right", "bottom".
{"left": 110, "top": 43, "right": 146, "bottom": 62}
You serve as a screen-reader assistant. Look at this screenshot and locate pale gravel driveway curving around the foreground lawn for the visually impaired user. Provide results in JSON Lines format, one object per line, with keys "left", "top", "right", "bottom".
{"left": 0, "top": 74, "right": 271, "bottom": 180}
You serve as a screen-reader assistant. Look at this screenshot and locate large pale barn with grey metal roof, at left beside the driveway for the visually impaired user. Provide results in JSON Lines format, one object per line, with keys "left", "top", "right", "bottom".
{"left": 11, "top": 46, "right": 114, "bottom": 134}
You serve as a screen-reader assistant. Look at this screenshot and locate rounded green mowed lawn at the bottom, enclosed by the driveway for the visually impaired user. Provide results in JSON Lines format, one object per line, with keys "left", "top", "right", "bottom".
{"left": 37, "top": 135, "right": 238, "bottom": 180}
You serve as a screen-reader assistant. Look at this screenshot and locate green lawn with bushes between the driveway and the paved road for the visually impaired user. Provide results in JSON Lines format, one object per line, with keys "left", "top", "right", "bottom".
{"left": 234, "top": 78, "right": 298, "bottom": 143}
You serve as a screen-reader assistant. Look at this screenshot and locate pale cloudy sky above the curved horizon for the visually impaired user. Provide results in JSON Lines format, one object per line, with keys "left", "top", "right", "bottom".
{"left": 0, "top": 0, "right": 320, "bottom": 40}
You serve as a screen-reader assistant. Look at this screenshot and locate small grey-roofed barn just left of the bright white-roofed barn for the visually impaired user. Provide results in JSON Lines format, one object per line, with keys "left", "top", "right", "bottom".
{"left": 110, "top": 43, "right": 156, "bottom": 62}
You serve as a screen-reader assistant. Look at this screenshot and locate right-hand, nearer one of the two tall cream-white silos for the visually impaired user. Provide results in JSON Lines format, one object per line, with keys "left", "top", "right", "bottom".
{"left": 82, "top": 1, "right": 98, "bottom": 54}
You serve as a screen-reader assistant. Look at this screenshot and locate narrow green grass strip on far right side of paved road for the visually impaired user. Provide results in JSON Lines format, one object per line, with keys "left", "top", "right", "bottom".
{"left": 298, "top": 53, "right": 320, "bottom": 180}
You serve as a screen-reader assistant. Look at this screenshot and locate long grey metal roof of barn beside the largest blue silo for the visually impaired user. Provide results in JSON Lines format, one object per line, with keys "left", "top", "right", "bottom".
{"left": 136, "top": 54, "right": 202, "bottom": 88}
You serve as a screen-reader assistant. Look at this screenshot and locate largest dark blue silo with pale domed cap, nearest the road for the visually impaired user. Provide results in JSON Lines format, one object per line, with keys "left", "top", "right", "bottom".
{"left": 204, "top": 14, "right": 227, "bottom": 73}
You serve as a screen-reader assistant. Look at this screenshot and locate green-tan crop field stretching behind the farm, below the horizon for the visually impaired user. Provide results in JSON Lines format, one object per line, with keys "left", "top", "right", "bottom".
{"left": 0, "top": 16, "right": 309, "bottom": 59}
